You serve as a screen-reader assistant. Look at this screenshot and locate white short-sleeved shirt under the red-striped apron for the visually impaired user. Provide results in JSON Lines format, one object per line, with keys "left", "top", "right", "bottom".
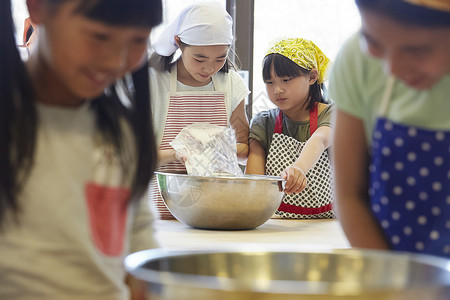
{"left": 149, "top": 68, "right": 250, "bottom": 146}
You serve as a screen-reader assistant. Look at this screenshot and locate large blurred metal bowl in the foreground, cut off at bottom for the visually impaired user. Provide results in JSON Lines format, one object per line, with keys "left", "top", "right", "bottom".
{"left": 125, "top": 249, "right": 450, "bottom": 300}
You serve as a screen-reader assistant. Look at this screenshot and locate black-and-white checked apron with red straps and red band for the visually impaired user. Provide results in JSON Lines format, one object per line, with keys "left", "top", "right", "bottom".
{"left": 266, "top": 104, "right": 334, "bottom": 219}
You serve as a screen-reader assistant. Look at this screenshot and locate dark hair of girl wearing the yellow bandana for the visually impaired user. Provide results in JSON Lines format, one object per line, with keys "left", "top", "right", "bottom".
{"left": 262, "top": 53, "right": 328, "bottom": 109}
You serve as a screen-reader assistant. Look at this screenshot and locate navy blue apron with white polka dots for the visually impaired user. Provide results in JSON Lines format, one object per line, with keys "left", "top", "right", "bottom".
{"left": 369, "top": 78, "right": 450, "bottom": 258}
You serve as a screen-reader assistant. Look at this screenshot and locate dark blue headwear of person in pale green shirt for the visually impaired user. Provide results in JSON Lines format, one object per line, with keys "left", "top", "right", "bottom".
{"left": 355, "top": 0, "right": 450, "bottom": 27}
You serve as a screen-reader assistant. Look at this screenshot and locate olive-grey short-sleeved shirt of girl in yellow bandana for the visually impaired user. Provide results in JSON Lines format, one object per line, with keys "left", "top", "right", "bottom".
{"left": 249, "top": 104, "right": 334, "bottom": 156}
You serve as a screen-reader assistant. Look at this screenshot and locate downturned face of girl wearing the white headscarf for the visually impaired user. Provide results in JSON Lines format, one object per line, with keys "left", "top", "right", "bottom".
{"left": 178, "top": 39, "right": 229, "bottom": 86}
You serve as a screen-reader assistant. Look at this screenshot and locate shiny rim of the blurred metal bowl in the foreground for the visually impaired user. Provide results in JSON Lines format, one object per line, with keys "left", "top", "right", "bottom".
{"left": 125, "top": 247, "right": 450, "bottom": 296}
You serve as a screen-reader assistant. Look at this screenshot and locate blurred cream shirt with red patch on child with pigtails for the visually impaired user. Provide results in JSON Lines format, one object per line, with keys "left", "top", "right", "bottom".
{"left": 0, "top": 104, "right": 157, "bottom": 300}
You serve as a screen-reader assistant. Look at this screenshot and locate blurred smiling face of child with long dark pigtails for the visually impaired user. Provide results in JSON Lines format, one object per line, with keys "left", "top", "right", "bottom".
{"left": 30, "top": 0, "right": 150, "bottom": 105}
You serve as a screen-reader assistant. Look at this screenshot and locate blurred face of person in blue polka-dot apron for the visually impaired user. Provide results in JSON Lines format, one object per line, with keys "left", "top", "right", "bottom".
{"left": 361, "top": 9, "right": 450, "bottom": 90}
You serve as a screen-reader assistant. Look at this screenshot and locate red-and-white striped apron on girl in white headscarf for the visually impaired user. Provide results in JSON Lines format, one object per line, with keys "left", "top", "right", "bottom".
{"left": 149, "top": 68, "right": 228, "bottom": 219}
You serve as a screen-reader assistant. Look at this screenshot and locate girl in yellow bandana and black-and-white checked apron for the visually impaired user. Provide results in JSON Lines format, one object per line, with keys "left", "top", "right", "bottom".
{"left": 246, "top": 38, "right": 334, "bottom": 219}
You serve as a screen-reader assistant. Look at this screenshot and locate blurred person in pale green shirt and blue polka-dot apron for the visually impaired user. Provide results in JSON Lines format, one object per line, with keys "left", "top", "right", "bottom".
{"left": 329, "top": 0, "right": 450, "bottom": 258}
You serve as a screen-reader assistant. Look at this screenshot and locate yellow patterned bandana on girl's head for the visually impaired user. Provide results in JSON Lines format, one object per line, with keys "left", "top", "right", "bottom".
{"left": 265, "top": 38, "right": 331, "bottom": 84}
